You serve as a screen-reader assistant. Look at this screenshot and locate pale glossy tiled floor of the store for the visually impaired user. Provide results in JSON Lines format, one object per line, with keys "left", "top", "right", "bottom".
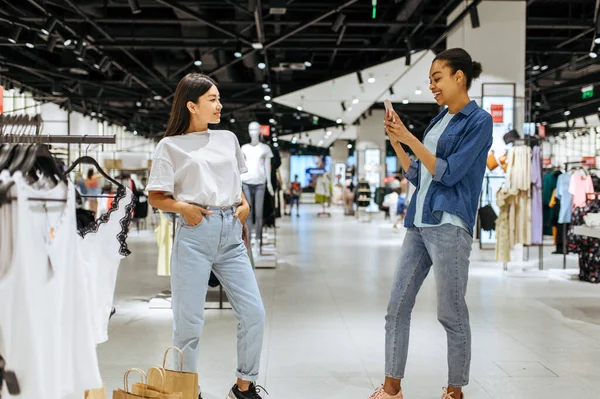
{"left": 99, "top": 206, "right": 600, "bottom": 399}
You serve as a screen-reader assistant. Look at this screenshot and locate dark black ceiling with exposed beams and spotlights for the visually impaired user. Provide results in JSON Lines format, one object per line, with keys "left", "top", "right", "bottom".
{"left": 0, "top": 0, "right": 600, "bottom": 142}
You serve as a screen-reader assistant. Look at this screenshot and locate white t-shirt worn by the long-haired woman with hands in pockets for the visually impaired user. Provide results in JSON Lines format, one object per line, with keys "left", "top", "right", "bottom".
{"left": 146, "top": 130, "right": 248, "bottom": 206}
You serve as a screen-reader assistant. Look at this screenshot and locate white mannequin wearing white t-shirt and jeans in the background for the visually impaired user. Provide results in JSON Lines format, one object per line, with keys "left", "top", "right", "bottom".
{"left": 242, "top": 122, "right": 275, "bottom": 240}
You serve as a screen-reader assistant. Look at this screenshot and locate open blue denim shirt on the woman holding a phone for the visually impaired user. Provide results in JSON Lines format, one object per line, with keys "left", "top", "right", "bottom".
{"left": 404, "top": 101, "right": 493, "bottom": 235}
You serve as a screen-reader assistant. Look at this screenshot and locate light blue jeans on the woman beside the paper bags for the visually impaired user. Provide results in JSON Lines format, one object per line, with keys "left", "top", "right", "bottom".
{"left": 171, "top": 207, "right": 265, "bottom": 381}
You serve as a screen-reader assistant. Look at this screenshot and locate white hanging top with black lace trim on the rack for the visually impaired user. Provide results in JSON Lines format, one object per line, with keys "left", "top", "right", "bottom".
{"left": 78, "top": 187, "right": 136, "bottom": 344}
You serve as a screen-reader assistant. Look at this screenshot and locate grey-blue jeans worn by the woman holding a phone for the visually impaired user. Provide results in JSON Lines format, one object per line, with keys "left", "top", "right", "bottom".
{"left": 385, "top": 224, "right": 473, "bottom": 387}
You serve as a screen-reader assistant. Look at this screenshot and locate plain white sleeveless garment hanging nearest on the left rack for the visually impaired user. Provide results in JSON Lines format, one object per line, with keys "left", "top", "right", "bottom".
{"left": 0, "top": 172, "right": 102, "bottom": 399}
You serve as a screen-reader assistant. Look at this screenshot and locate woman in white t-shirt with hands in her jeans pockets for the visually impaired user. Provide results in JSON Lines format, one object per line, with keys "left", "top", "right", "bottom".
{"left": 147, "top": 73, "right": 265, "bottom": 399}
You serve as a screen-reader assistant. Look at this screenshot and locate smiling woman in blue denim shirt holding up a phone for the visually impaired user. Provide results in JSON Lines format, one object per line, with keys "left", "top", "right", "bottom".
{"left": 371, "top": 49, "right": 492, "bottom": 399}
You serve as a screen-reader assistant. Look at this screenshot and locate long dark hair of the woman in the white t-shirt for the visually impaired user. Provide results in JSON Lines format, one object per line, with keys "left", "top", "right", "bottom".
{"left": 165, "top": 73, "right": 217, "bottom": 137}
